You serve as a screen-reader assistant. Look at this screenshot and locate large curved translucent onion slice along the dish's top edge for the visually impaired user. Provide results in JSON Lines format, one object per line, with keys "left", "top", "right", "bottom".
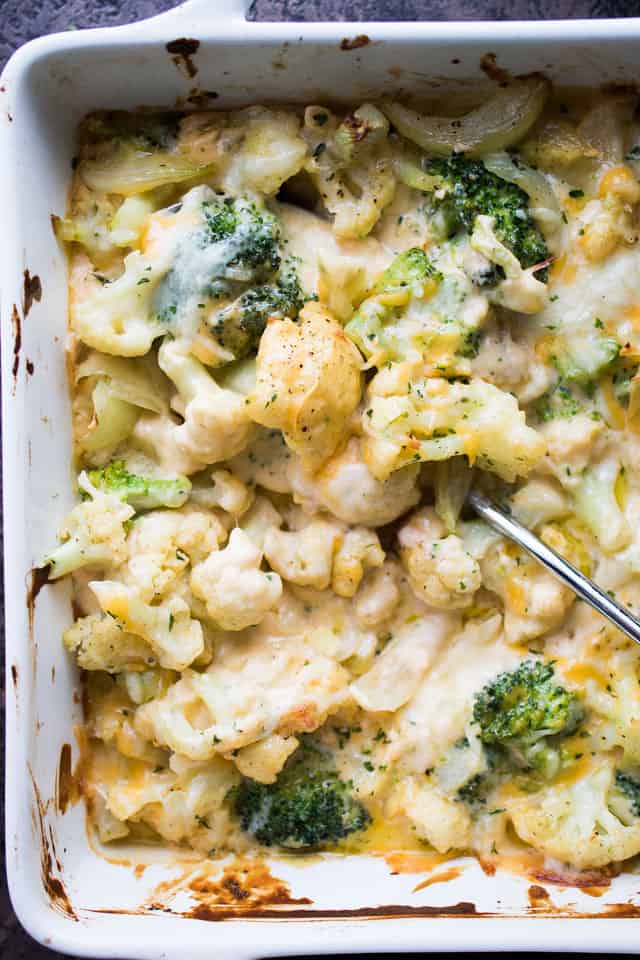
{"left": 380, "top": 75, "right": 550, "bottom": 157}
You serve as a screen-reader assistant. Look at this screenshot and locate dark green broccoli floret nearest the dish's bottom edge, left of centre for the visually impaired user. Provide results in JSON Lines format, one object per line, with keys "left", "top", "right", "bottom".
{"left": 232, "top": 748, "right": 371, "bottom": 849}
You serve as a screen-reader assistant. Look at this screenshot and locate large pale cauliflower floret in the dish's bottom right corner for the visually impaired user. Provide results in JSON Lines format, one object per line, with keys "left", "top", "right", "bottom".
{"left": 500, "top": 757, "right": 640, "bottom": 870}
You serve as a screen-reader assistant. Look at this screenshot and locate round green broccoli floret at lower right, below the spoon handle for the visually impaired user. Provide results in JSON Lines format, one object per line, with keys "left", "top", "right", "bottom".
{"left": 473, "top": 660, "right": 584, "bottom": 776}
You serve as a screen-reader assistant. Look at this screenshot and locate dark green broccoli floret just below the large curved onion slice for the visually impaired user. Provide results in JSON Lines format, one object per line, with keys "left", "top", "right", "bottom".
{"left": 425, "top": 154, "right": 549, "bottom": 270}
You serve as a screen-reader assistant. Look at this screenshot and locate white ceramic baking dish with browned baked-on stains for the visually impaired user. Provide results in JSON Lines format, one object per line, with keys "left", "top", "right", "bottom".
{"left": 6, "top": 0, "right": 640, "bottom": 960}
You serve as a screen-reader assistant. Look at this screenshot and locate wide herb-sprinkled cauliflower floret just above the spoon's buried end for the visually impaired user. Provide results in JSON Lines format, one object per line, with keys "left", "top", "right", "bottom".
{"left": 362, "top": 364, "right": 544, "bottom": 481}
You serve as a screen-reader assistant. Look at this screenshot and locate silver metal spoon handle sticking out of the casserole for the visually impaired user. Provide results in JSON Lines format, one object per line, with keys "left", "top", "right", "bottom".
{"left": 467, "top": 490, "right": 640, "bottom": 643}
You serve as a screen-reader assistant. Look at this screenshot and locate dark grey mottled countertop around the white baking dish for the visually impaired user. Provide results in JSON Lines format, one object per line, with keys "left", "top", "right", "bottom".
{"left": 0, "top": 0, "right": 640, "bottom": 960}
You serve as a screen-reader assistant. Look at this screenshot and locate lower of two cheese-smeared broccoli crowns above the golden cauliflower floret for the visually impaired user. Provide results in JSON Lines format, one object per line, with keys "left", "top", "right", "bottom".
{"left": 209, "top": 261, "right": 306, "bottom": 360}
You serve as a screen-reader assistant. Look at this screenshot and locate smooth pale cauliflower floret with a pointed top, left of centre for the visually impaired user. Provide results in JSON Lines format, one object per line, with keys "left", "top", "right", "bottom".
{"left": 191, "top": 527, "right": 282, "bottom": 630}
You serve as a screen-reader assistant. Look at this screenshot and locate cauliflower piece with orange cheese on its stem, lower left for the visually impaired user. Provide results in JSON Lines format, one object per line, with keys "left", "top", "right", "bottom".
{"left": 90, "top": 580, "right": 204, "bottom": 670}
